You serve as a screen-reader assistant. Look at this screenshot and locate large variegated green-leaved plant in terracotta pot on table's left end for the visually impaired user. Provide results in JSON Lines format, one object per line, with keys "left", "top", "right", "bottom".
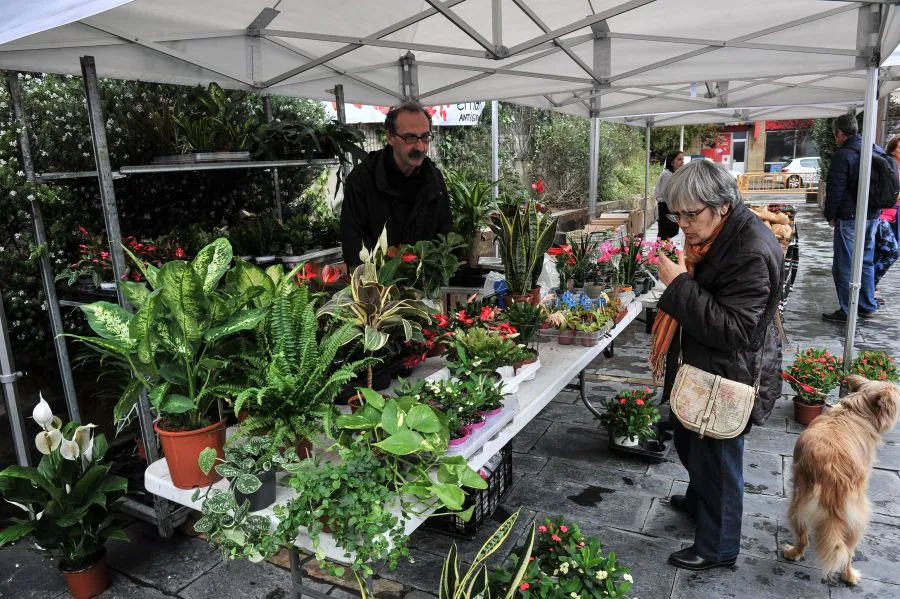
{"left": 73, "top": 239, "right": 271, "bottom": 489}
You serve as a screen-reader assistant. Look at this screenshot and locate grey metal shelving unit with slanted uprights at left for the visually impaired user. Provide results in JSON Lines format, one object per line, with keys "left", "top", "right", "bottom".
{"left": 0, "top": 61, "right": 343, "bottom": 537}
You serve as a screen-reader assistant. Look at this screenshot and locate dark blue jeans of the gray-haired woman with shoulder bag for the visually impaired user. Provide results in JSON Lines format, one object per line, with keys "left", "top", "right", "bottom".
{"left": 674, "top": 420, "right": 744, "bottom": 562}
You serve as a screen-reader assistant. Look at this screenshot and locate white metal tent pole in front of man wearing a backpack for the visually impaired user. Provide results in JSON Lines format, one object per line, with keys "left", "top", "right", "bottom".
{"left": 844, "top": 66, "right": 878, "bottom": 369}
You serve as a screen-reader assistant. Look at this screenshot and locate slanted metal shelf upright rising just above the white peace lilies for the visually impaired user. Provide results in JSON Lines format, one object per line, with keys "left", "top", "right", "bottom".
{"left": 6, "top": 75, "right": 81, "bottom": 422}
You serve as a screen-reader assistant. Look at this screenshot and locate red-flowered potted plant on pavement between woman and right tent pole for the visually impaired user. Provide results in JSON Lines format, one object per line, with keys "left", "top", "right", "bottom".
{"left": 784, "top": 348, "right": 843, "bottom": 425}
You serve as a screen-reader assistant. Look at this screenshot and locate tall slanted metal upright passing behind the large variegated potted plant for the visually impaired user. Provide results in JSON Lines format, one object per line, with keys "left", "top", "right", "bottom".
{"left": 81, "top": 56, "right": 173, "bottom": 538}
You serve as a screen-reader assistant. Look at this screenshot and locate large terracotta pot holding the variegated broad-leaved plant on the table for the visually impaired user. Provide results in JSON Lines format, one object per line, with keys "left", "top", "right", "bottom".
{"left": 153, "top": 420, "right": 225, "bottom": 489}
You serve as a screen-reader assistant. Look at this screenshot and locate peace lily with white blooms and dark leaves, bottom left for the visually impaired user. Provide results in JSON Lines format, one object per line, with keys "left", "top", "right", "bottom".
{"left": 0, "top": 397, "right": 128, "bottom": 570}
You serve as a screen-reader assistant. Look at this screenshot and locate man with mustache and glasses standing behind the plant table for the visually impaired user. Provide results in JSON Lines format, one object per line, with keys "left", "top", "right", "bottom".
{"left": 341, "top": 101, "right": 452, "bottom": 268}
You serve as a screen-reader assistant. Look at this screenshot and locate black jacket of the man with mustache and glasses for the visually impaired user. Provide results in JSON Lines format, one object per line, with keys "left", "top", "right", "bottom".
{"left": 341, "top": 146, "right": 452, "bottom": 268}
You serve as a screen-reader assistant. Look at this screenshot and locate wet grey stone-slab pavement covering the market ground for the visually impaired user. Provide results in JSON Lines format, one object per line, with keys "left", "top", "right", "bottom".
{"left": 0, "top": 206, "right": 900, "bottom": 599}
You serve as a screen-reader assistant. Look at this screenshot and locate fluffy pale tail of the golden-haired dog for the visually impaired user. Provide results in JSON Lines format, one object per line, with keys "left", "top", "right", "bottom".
{"left": 810, "top": 486, "right": 865, "bottom": 574}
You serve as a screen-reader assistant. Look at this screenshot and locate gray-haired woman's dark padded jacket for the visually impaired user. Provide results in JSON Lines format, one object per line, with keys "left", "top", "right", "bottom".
{"left": 659, "top": 204, "right": 784, "bottom": 424}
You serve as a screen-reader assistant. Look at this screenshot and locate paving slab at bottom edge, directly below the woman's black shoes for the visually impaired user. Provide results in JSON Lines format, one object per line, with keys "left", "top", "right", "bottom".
{"left": 671, "top": 555, "right": 829, "bottom": 599}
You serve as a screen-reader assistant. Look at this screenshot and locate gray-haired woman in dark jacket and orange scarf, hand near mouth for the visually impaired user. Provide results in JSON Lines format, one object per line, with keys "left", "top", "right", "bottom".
{"left": 650, "top": 160, "right": 783, "bottom": 570}
